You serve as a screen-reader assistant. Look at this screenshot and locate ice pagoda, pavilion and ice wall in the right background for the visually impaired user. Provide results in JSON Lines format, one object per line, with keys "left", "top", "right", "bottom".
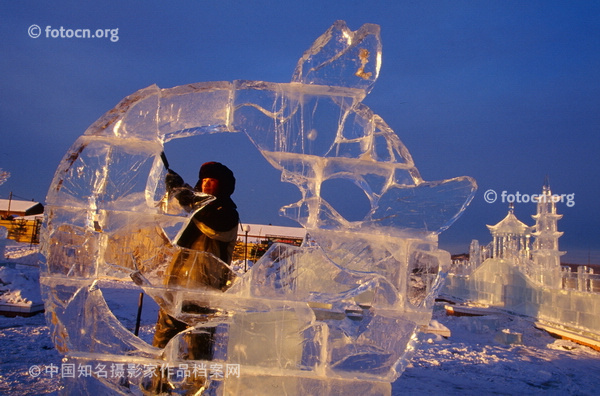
{"left": 441, "top": 183, "right": 600, "bottom": 350}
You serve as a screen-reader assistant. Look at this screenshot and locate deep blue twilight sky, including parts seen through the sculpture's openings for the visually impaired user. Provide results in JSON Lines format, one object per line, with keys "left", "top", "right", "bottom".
{"left": 0, "top": 0, "right": 600, "bottom": 263}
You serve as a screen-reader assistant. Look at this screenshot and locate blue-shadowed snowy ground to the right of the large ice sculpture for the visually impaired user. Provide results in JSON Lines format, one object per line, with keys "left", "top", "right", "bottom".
{"left": 393, "top": 303, "right": 600, "bottom": 395}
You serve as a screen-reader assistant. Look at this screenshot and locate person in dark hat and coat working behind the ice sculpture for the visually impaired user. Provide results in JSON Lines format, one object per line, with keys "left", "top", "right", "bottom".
{"left": 152, "top": 162, "right": 239, "bottom": 352}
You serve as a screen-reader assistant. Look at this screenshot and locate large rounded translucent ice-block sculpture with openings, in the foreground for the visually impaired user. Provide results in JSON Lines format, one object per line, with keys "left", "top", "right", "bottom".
{"left": 41, "top": 21, "right": 476, "bottom": 395}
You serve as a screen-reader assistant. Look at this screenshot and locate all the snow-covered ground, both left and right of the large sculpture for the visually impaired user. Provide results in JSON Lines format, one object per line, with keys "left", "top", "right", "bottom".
{"left": 0, "top": 245, "right": 600, "bottom": 395}
